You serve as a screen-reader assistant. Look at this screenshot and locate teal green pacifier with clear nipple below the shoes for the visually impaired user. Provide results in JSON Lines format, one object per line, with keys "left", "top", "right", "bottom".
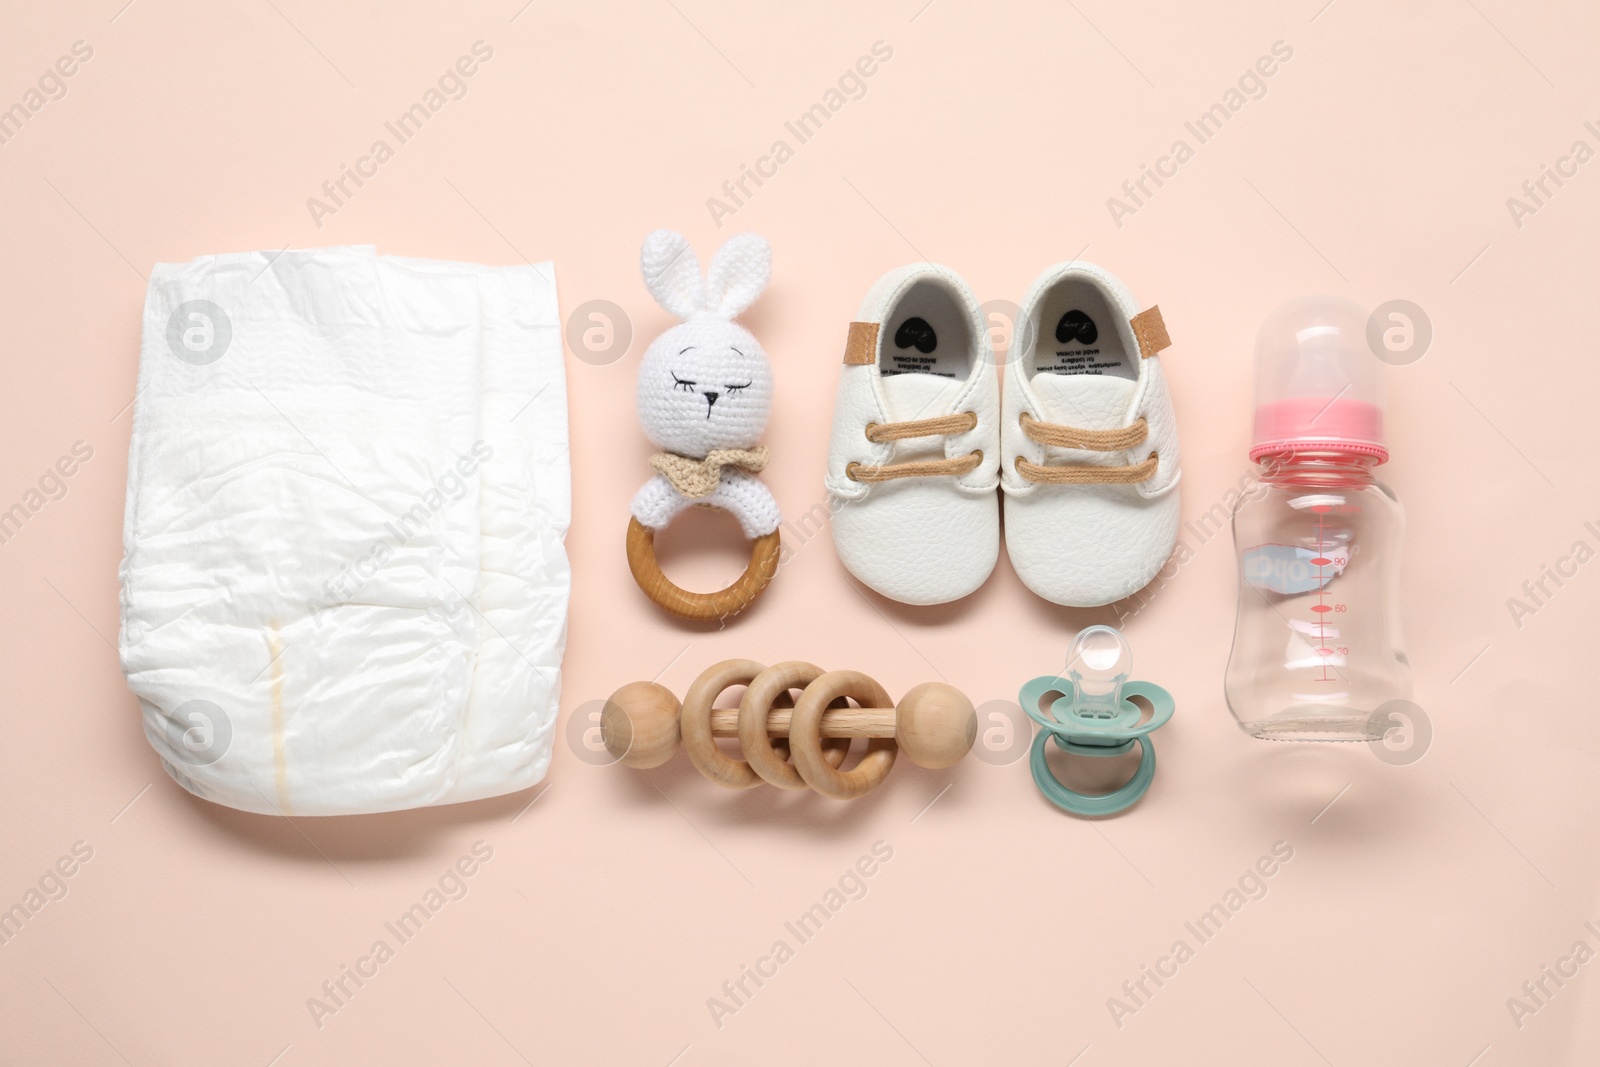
{"left": 1018, "top": 625, "right": 1176, "bottom": 816}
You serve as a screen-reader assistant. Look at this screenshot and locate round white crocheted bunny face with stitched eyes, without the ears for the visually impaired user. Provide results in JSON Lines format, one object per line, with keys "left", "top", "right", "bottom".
{"left": 638, "top": 315, "right": 773, "bottom": 459}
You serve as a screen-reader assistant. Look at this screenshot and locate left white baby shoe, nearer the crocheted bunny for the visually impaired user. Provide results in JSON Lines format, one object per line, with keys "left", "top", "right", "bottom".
{"left": 826, "top": 262, "right": 1000, "bottom": 605}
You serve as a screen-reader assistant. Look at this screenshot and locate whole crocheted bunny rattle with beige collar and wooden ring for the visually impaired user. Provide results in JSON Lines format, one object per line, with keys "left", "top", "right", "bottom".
{"left": 627, "top": 230, "right": 782, "bottom": 619}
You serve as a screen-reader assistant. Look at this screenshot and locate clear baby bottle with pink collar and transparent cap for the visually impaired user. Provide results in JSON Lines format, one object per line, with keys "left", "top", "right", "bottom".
{"left": 1224, "top": 298, "right": 1411, "bottom": 741}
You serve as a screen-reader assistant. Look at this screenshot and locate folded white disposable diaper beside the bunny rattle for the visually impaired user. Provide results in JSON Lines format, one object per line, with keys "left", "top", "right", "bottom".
{"left": 120, "top": 248, "right": 571, "bottom": 816}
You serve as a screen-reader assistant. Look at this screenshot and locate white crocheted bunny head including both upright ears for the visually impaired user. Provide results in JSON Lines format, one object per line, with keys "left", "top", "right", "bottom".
{"left": 637, "top": 230, "right": 773, "bottom": 459}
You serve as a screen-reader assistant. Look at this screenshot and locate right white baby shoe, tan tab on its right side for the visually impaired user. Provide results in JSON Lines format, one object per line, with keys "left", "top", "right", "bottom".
{"left": 1000, "top": 262, "right": 1179, "bottom": 608}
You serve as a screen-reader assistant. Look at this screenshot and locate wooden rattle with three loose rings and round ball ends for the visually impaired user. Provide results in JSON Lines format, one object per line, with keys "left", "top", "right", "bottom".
{"left": 600, "top": 659, "right": 978, "bottom": 800}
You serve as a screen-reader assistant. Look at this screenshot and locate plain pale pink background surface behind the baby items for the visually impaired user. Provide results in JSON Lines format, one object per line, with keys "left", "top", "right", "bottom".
{"left": 0, "top": 0, "right": 1600, "bottom": 1067}
